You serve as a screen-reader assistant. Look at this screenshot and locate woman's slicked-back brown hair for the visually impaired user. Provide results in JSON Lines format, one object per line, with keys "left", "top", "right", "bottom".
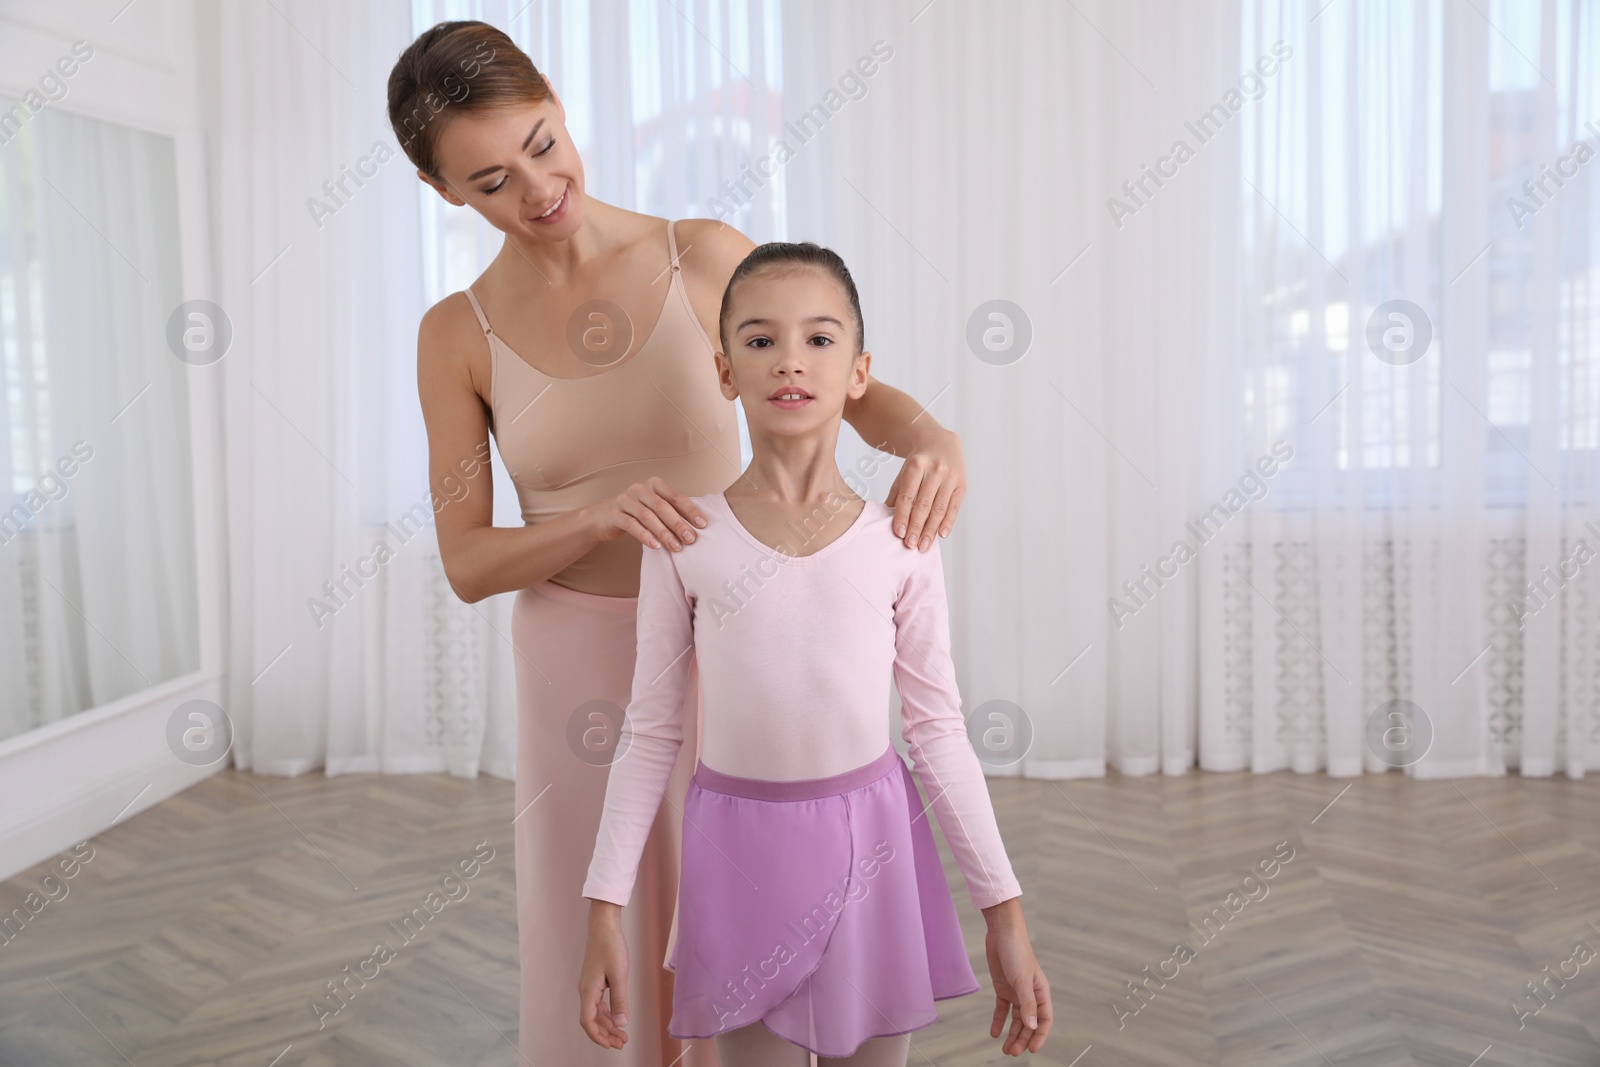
{"left": 389, "top": 21, "right": 550, "bottom": 182}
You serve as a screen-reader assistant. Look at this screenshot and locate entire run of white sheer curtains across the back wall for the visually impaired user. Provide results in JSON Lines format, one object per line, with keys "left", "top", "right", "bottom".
{"left": 203, "top": 0, "right": 1600, "bottom": 777}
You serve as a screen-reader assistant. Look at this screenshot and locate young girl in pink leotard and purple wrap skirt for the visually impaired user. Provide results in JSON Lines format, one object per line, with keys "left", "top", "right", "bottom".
{"left": 579, "top": 243, "right": 1051, "bottom": 1067}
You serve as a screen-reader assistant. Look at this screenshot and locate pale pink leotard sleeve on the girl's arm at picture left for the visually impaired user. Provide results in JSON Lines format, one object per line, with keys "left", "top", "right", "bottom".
{"left": 584, "top": 547, "right": 694, "bottom": 907}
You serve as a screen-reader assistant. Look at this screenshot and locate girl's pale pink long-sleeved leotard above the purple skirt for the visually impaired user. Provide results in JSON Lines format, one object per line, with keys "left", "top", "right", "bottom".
{"left": 584, "top": 493, "right": 1022, "bottom": 909}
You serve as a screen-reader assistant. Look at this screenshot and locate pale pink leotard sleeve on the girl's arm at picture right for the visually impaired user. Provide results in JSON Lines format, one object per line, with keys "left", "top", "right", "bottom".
{"left": 894, "top": 537, "right": 1022, "bottom": 910}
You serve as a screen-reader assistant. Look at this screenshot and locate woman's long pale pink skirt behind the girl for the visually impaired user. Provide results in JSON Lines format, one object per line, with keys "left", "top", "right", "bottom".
{"left": 510, "top": 582, "right": 717, "bottom": 1067}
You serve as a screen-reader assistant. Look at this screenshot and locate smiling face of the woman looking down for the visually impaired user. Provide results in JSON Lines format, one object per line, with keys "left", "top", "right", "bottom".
{"left": 418, "top": 90, "right": 584, "bottom": 242}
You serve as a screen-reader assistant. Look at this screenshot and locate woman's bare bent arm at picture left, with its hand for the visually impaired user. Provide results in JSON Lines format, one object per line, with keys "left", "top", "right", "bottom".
{"left": 416, "top": 298, "right": 706, "bottom": 603}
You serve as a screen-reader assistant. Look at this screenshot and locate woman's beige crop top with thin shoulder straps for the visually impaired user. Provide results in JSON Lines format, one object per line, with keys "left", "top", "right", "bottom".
{"left": 466, "top": 222, "right": 742, "bottom": 592}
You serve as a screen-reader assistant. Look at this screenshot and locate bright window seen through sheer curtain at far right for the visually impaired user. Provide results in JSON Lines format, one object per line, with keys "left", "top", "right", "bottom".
{"left": 1238, "top": 0, "right": 1600, "bottom": 507}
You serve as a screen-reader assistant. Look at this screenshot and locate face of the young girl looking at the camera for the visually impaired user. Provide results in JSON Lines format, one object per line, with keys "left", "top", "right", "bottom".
{"left": 717, "top": 266, "right": 872, "bottom": 437}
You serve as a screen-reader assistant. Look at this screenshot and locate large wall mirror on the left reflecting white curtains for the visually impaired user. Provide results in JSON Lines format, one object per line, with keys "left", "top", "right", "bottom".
{"left": 0, "top": 99, "right": 203, "bottom": 741}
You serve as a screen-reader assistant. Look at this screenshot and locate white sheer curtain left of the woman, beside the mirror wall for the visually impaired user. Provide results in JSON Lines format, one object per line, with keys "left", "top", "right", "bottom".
{"left": 198, "top": 0, "right": 480, "bottom": 776}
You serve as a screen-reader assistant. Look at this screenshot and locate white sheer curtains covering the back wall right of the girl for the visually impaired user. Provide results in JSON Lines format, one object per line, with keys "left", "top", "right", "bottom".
{"left": 784, "top": 0, "right": 1600, "bottom": 777}
